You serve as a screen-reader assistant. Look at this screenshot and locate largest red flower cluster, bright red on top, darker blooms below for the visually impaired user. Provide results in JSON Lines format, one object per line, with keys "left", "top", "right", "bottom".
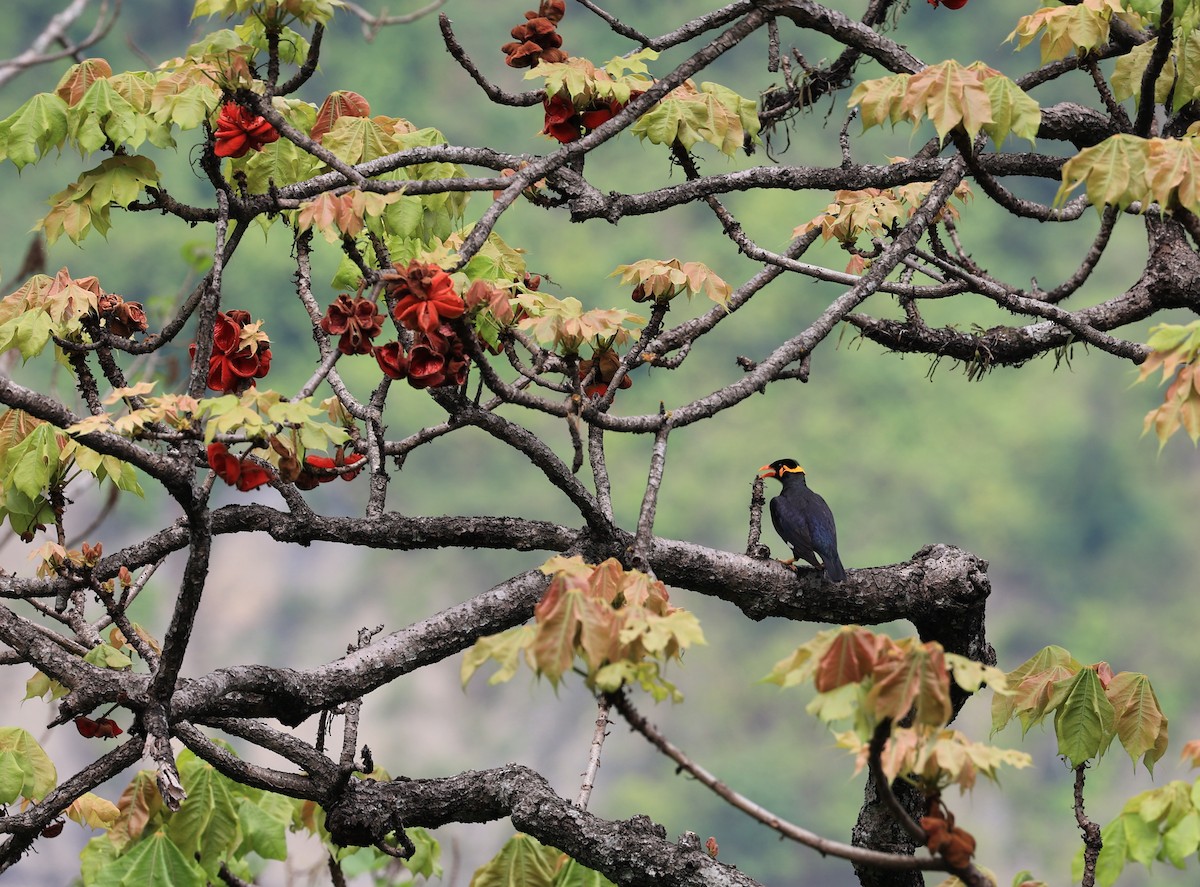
{"left": 373, "top": 262, "right": 469, "bottom": 388}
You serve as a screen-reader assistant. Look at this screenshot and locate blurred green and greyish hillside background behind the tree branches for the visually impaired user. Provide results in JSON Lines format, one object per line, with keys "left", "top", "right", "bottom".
{"left": 0, "top": 0, "right": 1200, "bottom": 887}
